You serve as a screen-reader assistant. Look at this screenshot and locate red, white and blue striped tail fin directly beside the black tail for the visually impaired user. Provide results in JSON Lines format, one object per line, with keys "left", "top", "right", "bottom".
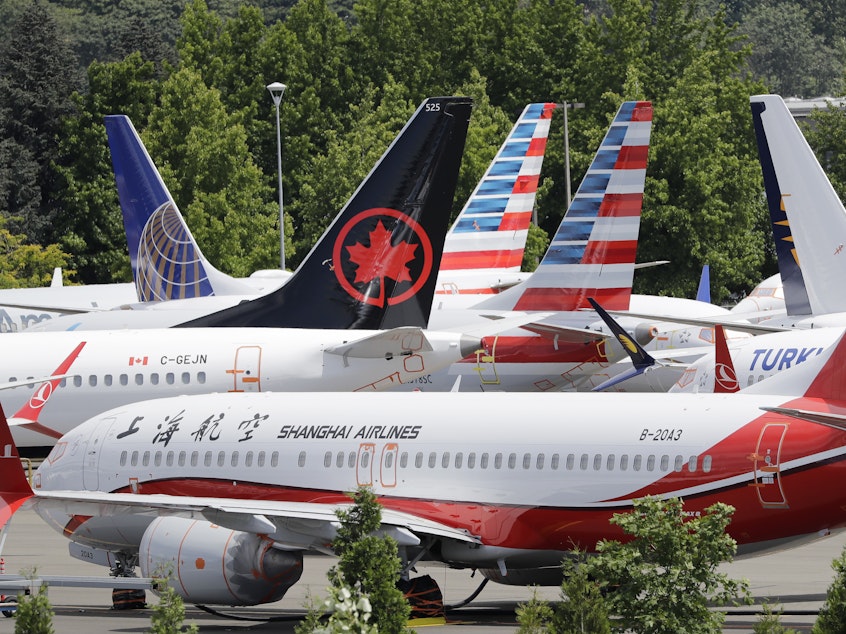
{"left": 437, "top": 103, "right": 555, "bottom": 294}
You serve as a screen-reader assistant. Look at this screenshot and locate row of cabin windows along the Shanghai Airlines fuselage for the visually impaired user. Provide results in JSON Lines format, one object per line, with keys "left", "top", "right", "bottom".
{"left": 120, "top": 450, "right": 711, "bottom": 473}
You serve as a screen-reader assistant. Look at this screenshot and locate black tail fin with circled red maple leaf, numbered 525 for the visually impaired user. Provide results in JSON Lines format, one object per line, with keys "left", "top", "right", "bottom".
{"left": 177, "top": 97, "right": 472, "bottom": 330}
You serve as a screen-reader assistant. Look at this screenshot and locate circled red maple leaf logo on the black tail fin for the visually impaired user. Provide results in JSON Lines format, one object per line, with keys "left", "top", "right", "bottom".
{"left": 333, "top": 207, "right": 433, "bottom": 306}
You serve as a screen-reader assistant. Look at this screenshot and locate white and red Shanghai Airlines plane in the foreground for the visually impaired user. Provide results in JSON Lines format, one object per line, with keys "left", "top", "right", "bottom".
{"left": 8, "top": 324, "right": 846, "bottom": 605}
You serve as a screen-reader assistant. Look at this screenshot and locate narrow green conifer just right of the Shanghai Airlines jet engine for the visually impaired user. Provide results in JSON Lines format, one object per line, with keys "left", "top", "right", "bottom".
{"left": 328, "top": 487, "right": 411, "bottom": 634}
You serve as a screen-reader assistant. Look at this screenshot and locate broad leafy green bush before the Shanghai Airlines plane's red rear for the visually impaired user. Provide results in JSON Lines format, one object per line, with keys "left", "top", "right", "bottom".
{"left": 582, "top": 497, "right": 748, "bottom": 634}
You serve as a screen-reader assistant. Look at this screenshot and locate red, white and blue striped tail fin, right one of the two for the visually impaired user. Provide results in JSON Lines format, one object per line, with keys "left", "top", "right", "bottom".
{"left": 475, "top": 101, "right": 652, "bottom": 311}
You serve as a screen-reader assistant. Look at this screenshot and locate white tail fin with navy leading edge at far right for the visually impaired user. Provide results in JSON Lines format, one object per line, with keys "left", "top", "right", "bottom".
{"left": 749, "top": 95, "right": 828, "bottom": 315}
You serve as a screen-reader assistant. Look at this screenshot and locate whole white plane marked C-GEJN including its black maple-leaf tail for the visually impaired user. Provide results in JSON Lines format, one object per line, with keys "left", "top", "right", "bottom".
{"left": 0, "top": 97, "right": 490, "bottom": 447}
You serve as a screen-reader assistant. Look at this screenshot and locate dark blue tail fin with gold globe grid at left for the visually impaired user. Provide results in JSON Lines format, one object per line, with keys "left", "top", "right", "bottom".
{"left": 106, "top": 115, "right": 255, "bottom": 302}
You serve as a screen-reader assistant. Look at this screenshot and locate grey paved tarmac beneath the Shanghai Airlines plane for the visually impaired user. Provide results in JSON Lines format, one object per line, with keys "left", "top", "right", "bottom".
{"left": 0, "top": 510, "right": 846, "bottom": 634}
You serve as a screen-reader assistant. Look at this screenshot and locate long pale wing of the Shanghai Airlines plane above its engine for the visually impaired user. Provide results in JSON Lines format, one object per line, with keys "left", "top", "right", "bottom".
{"left": 26, "top": 490, "right": 481, "bottom": 552}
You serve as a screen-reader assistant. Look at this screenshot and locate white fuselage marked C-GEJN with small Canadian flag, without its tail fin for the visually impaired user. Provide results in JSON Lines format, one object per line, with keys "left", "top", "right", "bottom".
{"left": 0, "top": 328, "right": 478, "bottom": 447}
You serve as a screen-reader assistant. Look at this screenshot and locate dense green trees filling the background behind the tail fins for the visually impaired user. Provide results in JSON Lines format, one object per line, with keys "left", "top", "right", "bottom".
{"left": 0, "top": 0, "right": 846, "bottom": 301}
